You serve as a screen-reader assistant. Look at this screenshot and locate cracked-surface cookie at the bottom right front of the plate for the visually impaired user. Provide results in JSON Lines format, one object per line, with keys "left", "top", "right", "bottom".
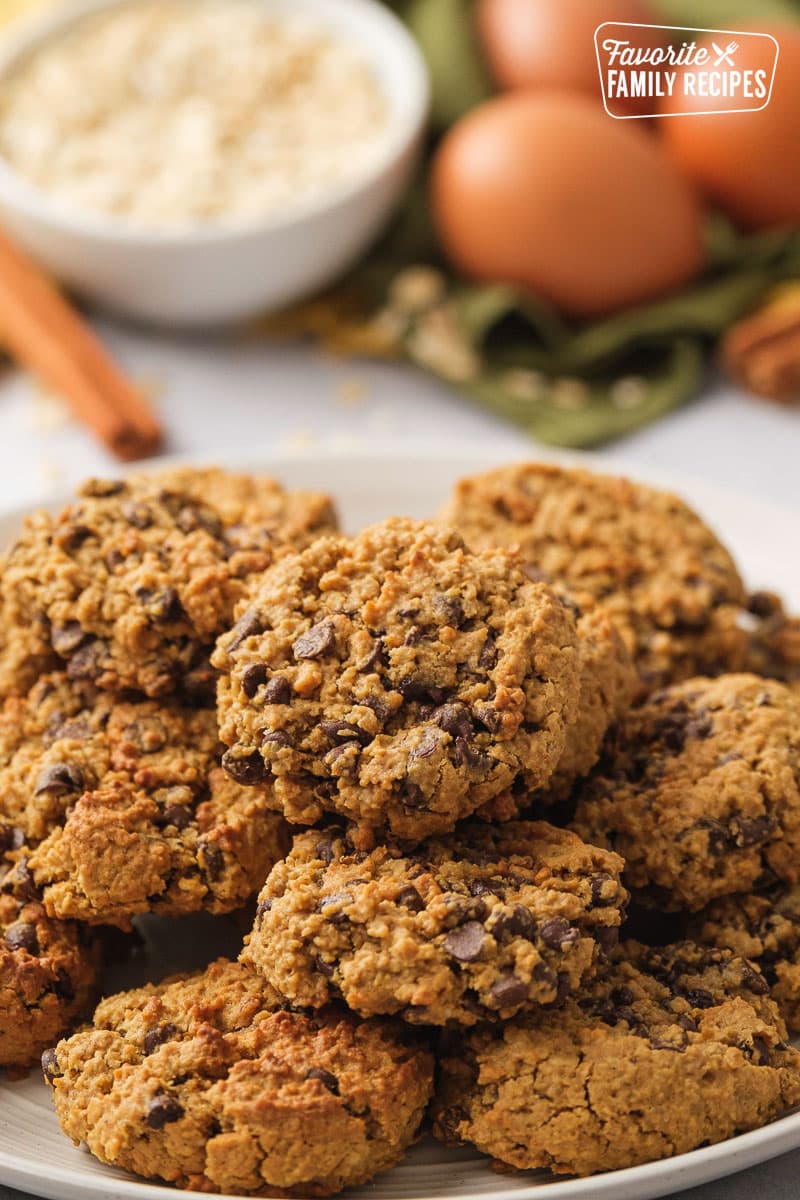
{"left": 434, "top": 943, "right": 800, "bottom": 1175}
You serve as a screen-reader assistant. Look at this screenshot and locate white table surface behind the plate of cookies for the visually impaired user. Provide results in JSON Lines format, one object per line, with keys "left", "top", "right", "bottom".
{"left": 0, "top": 312, "right": 800, "bottom": 1200}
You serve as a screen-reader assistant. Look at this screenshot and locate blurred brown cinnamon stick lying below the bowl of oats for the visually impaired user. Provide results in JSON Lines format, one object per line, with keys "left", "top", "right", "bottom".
{"left": 0, "top": 226, "right": 163, "bottom": 461}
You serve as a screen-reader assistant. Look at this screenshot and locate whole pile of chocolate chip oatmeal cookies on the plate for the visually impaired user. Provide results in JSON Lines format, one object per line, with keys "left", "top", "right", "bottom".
{"left": 0, "top": 466, "right": 800, "bottom": 1195}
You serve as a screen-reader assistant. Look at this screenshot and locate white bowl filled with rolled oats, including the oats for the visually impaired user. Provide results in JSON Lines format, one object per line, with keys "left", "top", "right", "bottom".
{"left": 0, "top": 0, "right": 428, "bottom": 326}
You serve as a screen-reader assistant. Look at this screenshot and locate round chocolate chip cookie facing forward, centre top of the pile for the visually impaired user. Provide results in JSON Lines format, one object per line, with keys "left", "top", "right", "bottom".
{"left": 213, "top": 518, "right": 579, "bottom": 841}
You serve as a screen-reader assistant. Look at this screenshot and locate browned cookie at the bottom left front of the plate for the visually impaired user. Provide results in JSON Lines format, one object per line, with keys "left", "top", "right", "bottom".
{"left": 42, "top": 960, "right": 433, "bottom": 1196}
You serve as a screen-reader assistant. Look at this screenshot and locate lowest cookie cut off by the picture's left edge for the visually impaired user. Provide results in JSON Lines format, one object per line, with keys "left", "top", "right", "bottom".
{"left": 0, "top": 892, "right": 100, "bottom": 1070}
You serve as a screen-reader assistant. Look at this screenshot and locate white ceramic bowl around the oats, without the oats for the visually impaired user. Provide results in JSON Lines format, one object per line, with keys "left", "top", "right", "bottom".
{"left": 0, "top": 0, "right": 428, "bottom": 326}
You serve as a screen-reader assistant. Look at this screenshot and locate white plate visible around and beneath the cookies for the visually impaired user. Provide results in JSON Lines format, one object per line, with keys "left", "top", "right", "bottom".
{"left": 0, "top": 450, "right": 800, "bottom": 1200}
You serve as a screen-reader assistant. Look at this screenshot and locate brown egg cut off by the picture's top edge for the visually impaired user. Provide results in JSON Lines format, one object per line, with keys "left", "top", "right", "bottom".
{"left": 476, "top": 0, "right": 661, "bottom": 113}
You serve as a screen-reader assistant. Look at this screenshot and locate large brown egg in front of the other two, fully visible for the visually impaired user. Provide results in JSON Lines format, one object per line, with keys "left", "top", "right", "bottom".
{"left": 432, "top": 91, "right": 703, "bottom": 317}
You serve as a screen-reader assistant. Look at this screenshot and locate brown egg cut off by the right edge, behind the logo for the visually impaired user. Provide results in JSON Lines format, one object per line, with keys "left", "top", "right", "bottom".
{"left": 658, "top": 26, "right": 800, "bottom": 229}
